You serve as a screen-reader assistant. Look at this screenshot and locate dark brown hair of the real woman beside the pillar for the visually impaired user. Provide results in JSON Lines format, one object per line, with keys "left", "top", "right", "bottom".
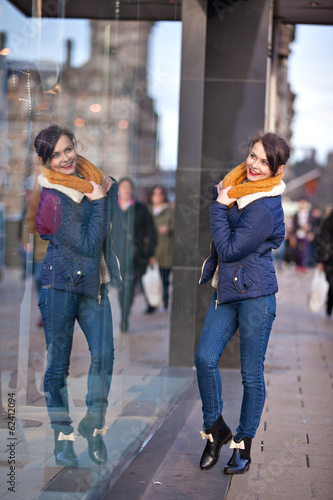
{"left": 248, "top": 132, "right": 290, "bottom": 175}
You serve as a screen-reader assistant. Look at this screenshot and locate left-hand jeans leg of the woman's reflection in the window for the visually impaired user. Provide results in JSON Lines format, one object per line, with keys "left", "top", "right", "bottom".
{"left": 39, "top": 288, "right": 77, "bottom": 434}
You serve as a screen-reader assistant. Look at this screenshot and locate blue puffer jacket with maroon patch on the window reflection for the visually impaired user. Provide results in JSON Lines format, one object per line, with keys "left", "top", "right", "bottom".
{"left": 36, "top": 178, "right": 121, "bottom": 298}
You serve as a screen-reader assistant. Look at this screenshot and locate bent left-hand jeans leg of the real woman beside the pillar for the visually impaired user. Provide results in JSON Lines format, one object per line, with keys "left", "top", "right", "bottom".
{"left": 195, "top": 292, "right": 238, "bottom": 429}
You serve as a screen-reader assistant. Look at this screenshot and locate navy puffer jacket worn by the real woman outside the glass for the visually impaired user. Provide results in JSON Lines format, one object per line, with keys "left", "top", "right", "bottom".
{"left": 199, "top": 183, "right": 285, "bottom": 304}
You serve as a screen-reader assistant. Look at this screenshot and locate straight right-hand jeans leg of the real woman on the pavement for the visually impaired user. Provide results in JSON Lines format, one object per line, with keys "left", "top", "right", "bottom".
{"left": 236, "top": 294, "right": 276, "bottom": 440}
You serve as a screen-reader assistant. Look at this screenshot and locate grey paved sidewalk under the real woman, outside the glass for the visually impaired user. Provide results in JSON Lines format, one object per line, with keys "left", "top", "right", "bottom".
{"left": 106, "top": 266, "right": 333, "bottom": 500}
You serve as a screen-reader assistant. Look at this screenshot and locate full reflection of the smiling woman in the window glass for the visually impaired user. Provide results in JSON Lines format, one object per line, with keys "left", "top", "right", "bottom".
{"left": 34, "top": 126, "right": 120, "bottom": 466}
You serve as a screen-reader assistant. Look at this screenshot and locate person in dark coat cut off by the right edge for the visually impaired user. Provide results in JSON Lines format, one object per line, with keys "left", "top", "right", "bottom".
{"left": 315, "top": 210, "right": 333, "bottom": 317}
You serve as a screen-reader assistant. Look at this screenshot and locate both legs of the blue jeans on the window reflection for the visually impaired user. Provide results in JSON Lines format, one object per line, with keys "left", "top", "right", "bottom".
{"left": 39, "top": 285, "right": 114, "bottom": 429}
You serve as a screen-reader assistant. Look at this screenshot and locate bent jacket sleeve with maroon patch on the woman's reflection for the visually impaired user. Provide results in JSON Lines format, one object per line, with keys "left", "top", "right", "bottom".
{"left": 36, "top": 188, "right": 107, "bottom": 257}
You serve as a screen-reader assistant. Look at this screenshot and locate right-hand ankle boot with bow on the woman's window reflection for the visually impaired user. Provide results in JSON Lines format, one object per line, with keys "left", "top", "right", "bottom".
{"left": 78, "top": 411, "right": 108, "bottom": 465}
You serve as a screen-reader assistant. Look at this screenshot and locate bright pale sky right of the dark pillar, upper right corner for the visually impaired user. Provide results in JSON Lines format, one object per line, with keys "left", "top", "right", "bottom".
{"left": 288, "top": 25, "right": 333, "bottom": 165}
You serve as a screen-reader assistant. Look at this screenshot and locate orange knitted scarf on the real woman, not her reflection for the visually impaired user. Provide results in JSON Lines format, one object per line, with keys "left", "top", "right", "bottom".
{"left": 223, "top": 162, "right": 283, "bottom": 198}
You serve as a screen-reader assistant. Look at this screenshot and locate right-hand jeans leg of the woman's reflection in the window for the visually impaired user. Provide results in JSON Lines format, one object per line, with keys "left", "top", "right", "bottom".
{"left": 78, "top": 285, "right": 114, "bottom": 428}
